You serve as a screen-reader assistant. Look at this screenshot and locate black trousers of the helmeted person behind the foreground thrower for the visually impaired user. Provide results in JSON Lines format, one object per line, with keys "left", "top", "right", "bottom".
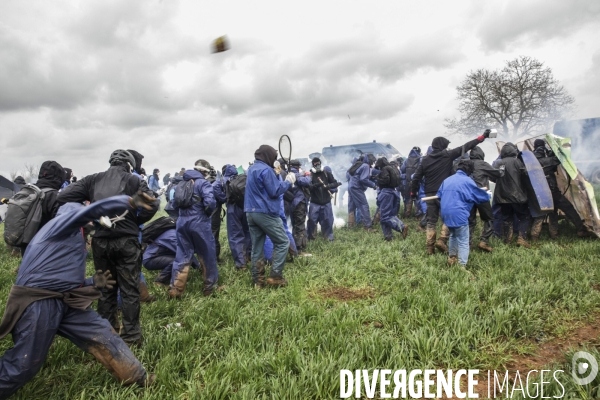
{"left": 92, "top": 236, "right": 142, "bottom": 342}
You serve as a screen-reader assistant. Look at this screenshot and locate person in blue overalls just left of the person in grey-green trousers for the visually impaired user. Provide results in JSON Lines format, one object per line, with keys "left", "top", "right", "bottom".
{"left": 213, "top": 164, "right": 252, "bottom": 270}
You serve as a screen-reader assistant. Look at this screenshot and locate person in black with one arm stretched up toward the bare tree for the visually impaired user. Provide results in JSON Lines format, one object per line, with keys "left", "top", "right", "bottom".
{"left": 411, "top": 129, "right": 490, "bottom": 254}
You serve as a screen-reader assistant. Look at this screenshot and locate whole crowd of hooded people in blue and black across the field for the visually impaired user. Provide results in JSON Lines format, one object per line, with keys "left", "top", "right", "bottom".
{"left": 0, "top": 130, "right": 588, "bottom": 399}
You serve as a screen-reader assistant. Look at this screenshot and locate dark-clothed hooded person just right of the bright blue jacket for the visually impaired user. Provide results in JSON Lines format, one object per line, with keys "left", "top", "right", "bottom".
{"left": 469, "top": 146, "right": 504, "bottom": 253}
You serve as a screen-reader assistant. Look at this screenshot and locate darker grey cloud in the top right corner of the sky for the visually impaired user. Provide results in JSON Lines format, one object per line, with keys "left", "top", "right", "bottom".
{"left": 472, "top": 0, "right": 600, "bottom": 50}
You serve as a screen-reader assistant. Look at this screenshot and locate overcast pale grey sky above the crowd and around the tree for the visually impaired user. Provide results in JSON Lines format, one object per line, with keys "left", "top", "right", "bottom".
{"left": 0, "top": 0, "right": 600, "bottom": 177}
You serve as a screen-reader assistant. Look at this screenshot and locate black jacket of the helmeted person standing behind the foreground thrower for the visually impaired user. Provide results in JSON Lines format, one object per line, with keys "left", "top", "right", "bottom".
{"left": 58, "top": 162, "right": 158, "bottom": 238}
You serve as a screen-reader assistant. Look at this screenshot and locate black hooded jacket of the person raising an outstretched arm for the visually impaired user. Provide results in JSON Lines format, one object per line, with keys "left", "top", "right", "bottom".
{"left": 411, "top": 136, "right": 481, "bottom": 196}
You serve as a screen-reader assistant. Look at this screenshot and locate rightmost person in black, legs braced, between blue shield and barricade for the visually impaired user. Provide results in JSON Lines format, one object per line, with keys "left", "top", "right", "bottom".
{"left": 531, "top": 139, "right": 588, "bottom": 241}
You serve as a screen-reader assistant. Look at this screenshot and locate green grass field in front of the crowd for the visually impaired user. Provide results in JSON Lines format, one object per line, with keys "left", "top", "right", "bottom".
{"left": 0, "top": 193, "right": 600, "bottom": 399}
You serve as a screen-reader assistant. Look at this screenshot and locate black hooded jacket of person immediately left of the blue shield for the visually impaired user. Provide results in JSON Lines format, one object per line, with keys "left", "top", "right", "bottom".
{"left": 494, "top": 142, "right": 527, "bottom": 204}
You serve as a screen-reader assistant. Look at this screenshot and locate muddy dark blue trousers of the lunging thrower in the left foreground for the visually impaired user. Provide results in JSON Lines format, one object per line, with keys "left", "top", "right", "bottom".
{"left": 0, "top": 298, "right": 146, "bottom": 399}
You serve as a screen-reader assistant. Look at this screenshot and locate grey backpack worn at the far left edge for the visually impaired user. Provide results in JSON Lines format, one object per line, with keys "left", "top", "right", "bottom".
{"left": 4, "top": 185, "right": 54, "bottom": 246}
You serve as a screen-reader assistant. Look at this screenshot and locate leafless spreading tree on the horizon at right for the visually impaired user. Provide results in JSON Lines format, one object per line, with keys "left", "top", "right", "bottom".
{"left": 445, "top": 56, "right": 575, "bottom": 140}
